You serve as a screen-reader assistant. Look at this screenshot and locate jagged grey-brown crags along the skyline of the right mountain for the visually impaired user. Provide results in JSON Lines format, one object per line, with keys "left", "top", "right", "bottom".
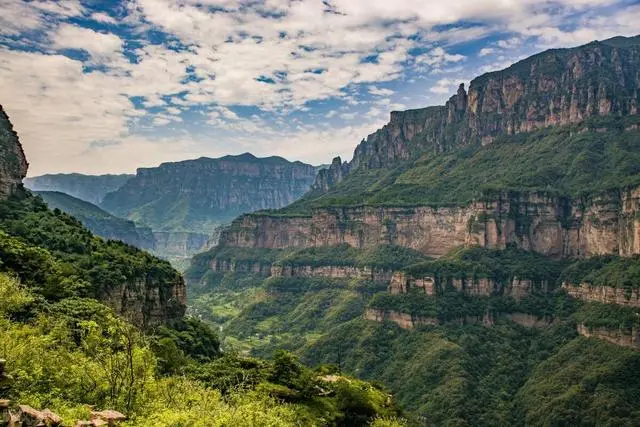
{"left": 314, "top": 37, "right": 640, "bottom": 189}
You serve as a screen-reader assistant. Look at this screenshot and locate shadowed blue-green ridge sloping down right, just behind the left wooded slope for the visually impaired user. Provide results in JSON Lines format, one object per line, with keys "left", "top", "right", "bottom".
{"left": 35, "top": 191, "right": 155, "bottom": 250}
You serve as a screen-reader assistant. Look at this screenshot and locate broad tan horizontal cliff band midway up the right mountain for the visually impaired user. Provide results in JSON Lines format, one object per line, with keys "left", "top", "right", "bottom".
{"left": 220, "top": 188, "right": 640, "bottom": 257}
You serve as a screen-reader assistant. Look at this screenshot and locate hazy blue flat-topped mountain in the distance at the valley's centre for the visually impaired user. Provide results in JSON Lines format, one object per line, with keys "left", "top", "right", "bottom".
{"left": 101, "top": 153, "right": 316, "bottom": 234}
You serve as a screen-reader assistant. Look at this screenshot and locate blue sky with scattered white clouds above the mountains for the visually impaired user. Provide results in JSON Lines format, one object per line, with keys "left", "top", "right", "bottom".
{"left": 0, "top": 0, "right": 640, "bottom": 176}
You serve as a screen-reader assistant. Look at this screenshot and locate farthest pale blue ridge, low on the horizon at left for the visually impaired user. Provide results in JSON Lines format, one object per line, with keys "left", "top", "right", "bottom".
{"left": 24, "top": 173, "right": 133, "bottom": 205}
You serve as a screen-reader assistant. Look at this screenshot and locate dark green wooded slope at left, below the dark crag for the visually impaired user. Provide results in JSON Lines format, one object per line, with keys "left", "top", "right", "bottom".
{"left": 0, "top": 194, "right": 180, "bottom": 308}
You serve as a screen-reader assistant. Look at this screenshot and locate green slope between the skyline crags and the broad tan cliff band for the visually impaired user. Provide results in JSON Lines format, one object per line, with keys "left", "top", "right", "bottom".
{"left": 282, "top": 117, "right": 640, "bottom": 215}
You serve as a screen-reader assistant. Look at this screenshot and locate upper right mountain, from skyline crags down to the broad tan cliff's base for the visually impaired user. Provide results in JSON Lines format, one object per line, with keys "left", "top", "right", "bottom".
{"left": 222, "top": 37, "right": 640, "bottom": 257}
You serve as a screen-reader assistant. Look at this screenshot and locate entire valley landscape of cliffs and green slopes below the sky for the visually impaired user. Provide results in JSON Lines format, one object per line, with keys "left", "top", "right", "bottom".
{"left": 0, "top": 31, "right": 640, "bottom": 427}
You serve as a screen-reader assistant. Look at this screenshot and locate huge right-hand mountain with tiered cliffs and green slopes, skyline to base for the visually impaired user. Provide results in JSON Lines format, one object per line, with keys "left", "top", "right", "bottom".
{"left": 185, "top": 37, "right": 640, "bottom": 426}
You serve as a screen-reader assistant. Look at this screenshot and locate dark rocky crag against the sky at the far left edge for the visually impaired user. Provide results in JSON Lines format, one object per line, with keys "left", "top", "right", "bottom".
{"left": 0, "top": 105, "right": 29, "bottom": 198}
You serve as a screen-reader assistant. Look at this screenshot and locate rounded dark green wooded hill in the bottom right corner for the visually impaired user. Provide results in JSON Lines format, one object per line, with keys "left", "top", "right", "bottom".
{"left": 514, "top": 338, "right": 640, "bottom": 426}
